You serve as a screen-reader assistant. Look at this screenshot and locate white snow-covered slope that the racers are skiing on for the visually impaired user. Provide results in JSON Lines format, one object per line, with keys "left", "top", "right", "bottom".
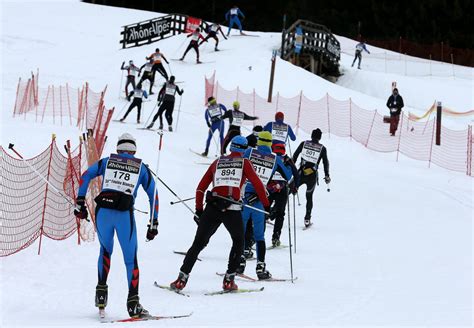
{"left": 0, "top": 1, "right": 473, "bottom": 327}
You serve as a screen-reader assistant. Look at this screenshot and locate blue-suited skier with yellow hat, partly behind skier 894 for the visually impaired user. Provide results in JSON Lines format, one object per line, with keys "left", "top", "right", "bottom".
{"left": 238, "top": 131, "right": 291, "bottom": 280}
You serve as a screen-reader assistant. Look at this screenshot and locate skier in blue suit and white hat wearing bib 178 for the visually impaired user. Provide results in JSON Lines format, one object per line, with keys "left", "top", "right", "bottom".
{"left": 74, "top": 133, "right": 159, "bottom": 317}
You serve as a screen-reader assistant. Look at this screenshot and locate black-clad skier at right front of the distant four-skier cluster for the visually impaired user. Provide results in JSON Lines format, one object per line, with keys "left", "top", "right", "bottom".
{"left": 146, "top": 75, "right": 184, "bottom": 132}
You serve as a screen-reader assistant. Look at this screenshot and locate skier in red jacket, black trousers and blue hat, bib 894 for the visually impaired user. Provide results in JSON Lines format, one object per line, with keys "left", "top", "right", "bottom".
{"left": 170, "top": 136, "right": 269, "bottom": 290}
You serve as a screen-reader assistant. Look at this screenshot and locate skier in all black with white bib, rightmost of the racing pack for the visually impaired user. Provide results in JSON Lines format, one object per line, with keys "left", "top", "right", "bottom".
{"left": 293, "top": 129, "right": 331, "bottom": 227}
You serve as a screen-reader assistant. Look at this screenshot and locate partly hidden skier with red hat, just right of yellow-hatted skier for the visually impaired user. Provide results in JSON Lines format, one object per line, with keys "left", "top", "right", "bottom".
{"left": 267, "top": 144, "right": 299, "bottom": 247}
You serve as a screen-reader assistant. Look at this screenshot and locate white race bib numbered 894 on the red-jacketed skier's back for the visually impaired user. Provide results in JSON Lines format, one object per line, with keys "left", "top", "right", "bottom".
{"left": 214, "top": 158, "right": 244, "bottom": 188}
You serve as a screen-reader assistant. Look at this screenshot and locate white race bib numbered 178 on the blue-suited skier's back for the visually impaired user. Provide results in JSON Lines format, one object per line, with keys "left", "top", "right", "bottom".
{"left": 103, "top": 154, "right": 142, "bottom": 195}
